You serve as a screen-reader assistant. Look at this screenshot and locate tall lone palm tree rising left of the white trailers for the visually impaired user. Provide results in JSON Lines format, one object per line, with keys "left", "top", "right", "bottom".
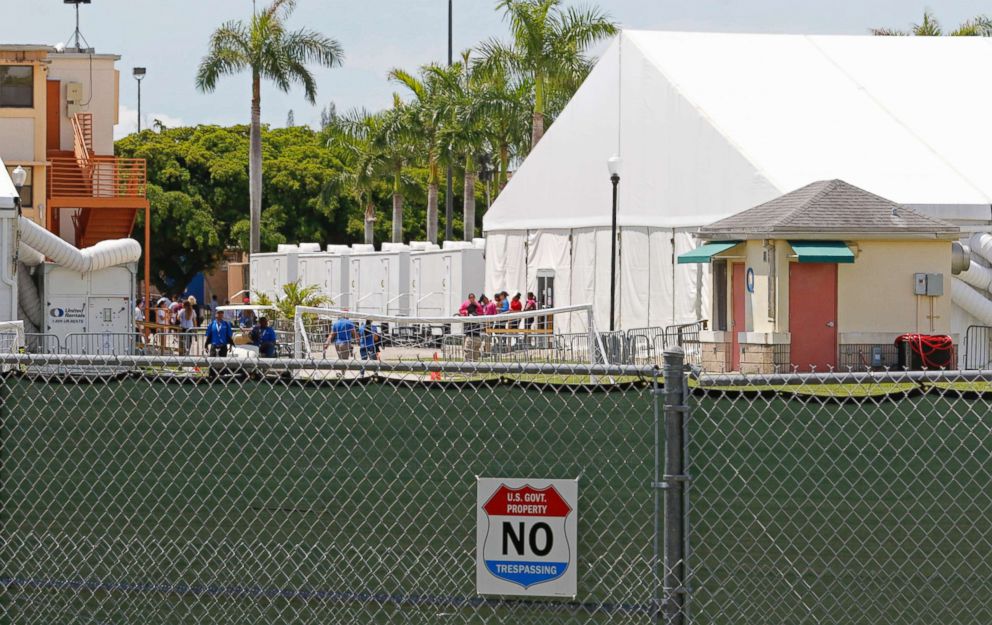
{"left": 196, "top": 0, "right": 344, "bottom": 254}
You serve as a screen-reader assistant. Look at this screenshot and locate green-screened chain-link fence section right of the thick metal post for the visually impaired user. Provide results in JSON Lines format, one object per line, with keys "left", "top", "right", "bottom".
{"left": 687, "top": 372, "right": 992, "bottom": 625}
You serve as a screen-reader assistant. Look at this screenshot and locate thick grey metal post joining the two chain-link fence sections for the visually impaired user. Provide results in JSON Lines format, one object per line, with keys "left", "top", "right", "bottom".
{"left": 662, "top": 346, "right": 689, "bottom": 625}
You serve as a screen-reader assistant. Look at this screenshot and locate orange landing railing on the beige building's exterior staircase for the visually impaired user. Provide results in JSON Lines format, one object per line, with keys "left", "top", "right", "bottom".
{"left": 48, "top": 156, "right": 147, "bottom": 199}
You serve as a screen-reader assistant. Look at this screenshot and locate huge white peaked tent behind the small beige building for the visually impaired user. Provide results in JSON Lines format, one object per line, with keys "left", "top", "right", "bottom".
{"left": 483, "top": 31, "right": 992, "bottom": 329}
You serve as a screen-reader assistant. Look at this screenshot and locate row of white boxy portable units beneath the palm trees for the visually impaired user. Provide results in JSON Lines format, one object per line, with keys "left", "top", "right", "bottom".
{"left": 250, "top": 239, "right": 486, "bottom": 317}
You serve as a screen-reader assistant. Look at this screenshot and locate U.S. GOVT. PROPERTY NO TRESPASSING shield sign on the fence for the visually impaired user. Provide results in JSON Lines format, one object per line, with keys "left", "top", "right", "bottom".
{"left": 476, "top": 477, "right": 579, "bottom": 597}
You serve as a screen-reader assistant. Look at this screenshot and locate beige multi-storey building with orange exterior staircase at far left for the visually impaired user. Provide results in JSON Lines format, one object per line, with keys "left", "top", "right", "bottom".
{"left": 0, "top": 45, "right": 150, "bottom": 300}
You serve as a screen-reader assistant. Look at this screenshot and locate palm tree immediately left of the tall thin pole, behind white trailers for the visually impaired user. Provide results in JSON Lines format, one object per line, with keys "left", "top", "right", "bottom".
{"left": 389, "top": 66, "right": 449, "bottom": 243}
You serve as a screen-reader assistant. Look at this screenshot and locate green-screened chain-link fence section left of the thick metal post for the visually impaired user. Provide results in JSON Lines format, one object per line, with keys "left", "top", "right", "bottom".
{"left": 0, "top": 355, "right": 661, "bottom": 625}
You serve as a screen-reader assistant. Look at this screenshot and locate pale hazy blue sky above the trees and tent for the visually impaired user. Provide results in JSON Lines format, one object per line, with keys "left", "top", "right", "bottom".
{"left": 0, "top": 0, "right": 992, "bottom": 134}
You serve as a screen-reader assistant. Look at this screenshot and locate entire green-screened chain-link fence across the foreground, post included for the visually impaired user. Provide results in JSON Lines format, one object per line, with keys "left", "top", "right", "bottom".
{"left": 0, "top": 349, "right": 992, "bottom": 625}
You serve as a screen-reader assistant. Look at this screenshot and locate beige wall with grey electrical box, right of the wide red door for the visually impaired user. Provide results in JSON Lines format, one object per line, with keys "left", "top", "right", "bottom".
{"left": 837, "top": 241, "right": 951, "bottom": 343}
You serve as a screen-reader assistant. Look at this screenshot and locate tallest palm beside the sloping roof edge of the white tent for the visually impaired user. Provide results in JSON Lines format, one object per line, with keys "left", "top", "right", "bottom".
{"left": 479, "top": 0, "right": 617, "bottom": 149}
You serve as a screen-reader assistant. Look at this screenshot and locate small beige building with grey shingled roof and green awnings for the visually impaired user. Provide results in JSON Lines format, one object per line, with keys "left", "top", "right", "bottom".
{"left": 679, "top": 180, "right": 960, "bottom": 372}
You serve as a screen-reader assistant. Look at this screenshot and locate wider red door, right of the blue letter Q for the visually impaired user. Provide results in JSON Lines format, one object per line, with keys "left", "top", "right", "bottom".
{"left": 789, "top": 263, "right": 837, "bottom": 372}
